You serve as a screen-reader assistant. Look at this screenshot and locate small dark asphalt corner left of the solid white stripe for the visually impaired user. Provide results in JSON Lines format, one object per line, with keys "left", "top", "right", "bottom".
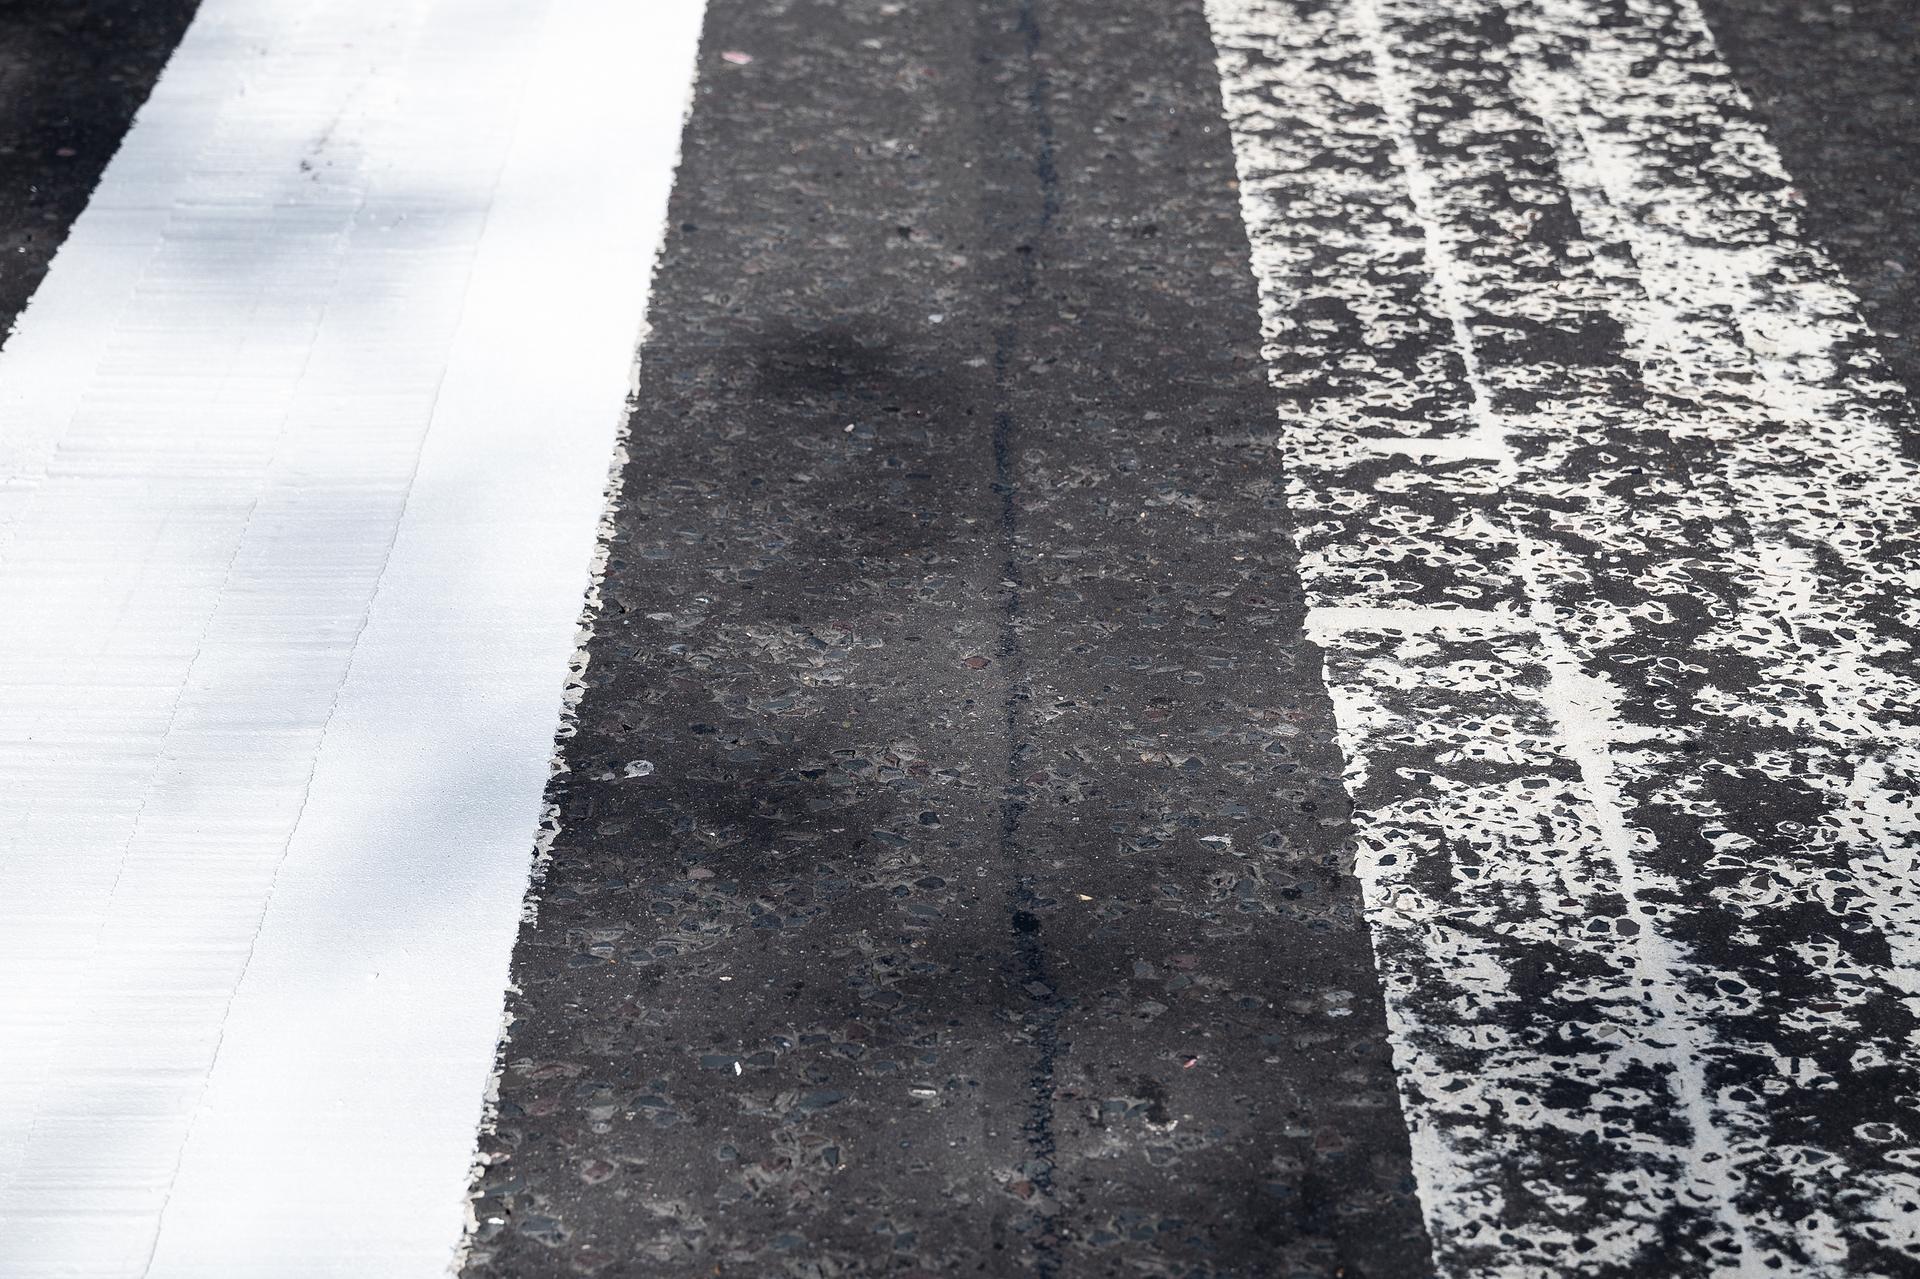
{"left": 0, "top": 0, "right": 200, "bottom": 334}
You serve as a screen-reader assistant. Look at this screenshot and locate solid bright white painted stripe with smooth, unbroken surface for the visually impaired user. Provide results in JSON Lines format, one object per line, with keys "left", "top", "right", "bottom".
{"left": 0, "top": 0, "right": 699, "bottom": 1275}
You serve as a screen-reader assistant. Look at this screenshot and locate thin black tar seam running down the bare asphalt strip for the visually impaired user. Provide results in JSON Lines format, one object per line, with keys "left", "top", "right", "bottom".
{"left": 993, "top": 0, "right": 1066, "bottom": 1279}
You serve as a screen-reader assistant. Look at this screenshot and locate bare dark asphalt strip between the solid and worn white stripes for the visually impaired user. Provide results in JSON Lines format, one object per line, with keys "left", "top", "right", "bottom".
{"left": 468, "top": 0, "right": 1428, "bottom": 1277}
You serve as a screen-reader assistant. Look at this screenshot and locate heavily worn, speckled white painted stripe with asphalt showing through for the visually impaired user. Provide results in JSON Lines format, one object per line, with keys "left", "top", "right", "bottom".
{"left": 1210, "top": 0, "right": 1920, "bottom": 1275}
